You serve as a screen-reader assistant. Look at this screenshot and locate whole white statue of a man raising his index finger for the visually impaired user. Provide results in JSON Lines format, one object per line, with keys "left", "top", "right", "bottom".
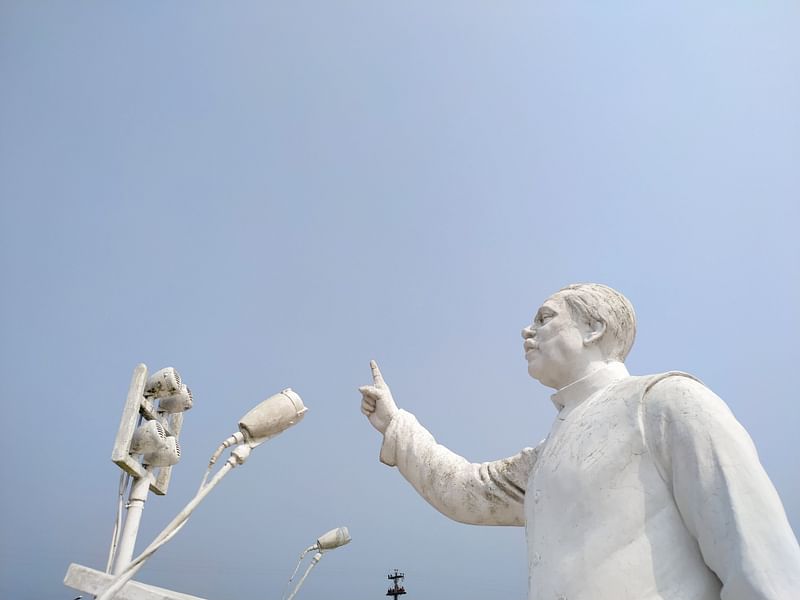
{"left": 359, "top": 284, "right": 800, "bottom": 600}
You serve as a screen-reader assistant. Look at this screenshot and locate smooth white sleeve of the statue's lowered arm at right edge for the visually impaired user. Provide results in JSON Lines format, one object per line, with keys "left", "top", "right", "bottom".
{"left": 643, "top": 376, "right": 800, "bottom": 600}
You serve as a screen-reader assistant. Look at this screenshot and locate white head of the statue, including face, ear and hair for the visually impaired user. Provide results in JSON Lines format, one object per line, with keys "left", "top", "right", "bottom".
{"left": 522, "top": 283, "right": 636, "bottom": 389}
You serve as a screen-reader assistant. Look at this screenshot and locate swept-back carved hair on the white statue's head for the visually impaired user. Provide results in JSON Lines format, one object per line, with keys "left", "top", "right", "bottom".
{"left": 558, "top": 283, "right": 636, "bottom": 362}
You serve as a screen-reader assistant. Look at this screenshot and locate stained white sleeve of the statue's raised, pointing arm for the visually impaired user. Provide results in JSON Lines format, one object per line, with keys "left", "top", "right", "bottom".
{"left": 380, "top": 410, "right": 537, "bottom": 526}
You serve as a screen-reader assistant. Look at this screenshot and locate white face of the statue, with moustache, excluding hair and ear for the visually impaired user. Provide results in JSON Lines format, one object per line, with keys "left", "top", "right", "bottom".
{"left": 522, "top": 294, "right": 585, "bottom": 389}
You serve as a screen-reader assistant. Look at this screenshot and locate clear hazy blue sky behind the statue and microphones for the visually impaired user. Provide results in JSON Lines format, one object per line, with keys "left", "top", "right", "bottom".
{"left": 0, "top": 0, "right": 800, "bottom": 600}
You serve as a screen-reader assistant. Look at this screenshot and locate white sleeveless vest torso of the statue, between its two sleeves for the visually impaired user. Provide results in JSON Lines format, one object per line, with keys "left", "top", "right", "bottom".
{"left": 525, "top": 373, "right": 720, "bottom": 600}
